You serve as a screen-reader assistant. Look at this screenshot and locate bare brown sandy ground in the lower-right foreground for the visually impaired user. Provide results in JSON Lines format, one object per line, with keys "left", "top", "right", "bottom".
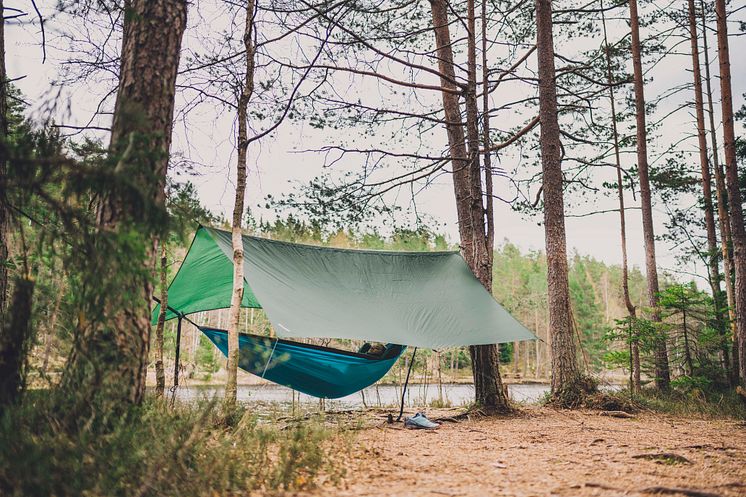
{"left": 312, "top": 407, "right": 746, "bottom": 497}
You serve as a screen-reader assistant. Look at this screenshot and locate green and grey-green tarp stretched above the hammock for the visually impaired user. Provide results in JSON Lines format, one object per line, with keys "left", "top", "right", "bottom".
{"left": 153, "top": 227, "right": 536, "bottom": 349}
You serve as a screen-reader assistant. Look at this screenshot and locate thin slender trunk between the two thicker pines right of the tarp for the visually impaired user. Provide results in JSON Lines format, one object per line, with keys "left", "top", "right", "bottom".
{"left": 601, "top": 5, "right": 641, "bottom": 393}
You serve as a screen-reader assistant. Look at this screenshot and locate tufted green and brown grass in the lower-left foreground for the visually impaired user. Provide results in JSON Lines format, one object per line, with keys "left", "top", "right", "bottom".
{"left": 0, "top": 396, "right": 350, "bottom": 497}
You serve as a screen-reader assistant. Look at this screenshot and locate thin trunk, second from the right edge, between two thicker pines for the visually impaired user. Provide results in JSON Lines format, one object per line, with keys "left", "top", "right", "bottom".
{"left": 700, "top": 0, "right": 739, "bottom": 386}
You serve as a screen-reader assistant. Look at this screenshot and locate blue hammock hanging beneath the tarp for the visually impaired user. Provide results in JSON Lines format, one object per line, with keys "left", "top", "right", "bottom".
{"left": 199, "top": 326, "right": 406, "bottom": 399}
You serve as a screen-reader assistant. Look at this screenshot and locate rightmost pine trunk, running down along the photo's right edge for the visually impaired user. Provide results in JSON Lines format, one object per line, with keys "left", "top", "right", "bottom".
{"left": 715, "top": 0, "right": 746, "bottom": 383}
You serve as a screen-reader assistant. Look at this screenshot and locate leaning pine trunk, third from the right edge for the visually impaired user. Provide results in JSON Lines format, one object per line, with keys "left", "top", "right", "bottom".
{"left": 688, "top": 0, "right": 730, "bottom": 378}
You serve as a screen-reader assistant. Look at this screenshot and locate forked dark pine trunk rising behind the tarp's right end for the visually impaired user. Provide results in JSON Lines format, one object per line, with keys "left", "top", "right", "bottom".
{"left": 430, "top": 0, "right": 510, "bottom": 412}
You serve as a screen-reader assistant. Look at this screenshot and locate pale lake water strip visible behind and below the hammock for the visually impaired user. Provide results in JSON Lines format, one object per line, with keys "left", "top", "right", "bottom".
{"left": 170, "top": 383, "right": 549, "bottom": 409}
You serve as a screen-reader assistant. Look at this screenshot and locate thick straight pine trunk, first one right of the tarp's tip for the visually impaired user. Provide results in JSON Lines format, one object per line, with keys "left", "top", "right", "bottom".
{"left": 536, "top": 0, "right": 580, "bottom": 400}
